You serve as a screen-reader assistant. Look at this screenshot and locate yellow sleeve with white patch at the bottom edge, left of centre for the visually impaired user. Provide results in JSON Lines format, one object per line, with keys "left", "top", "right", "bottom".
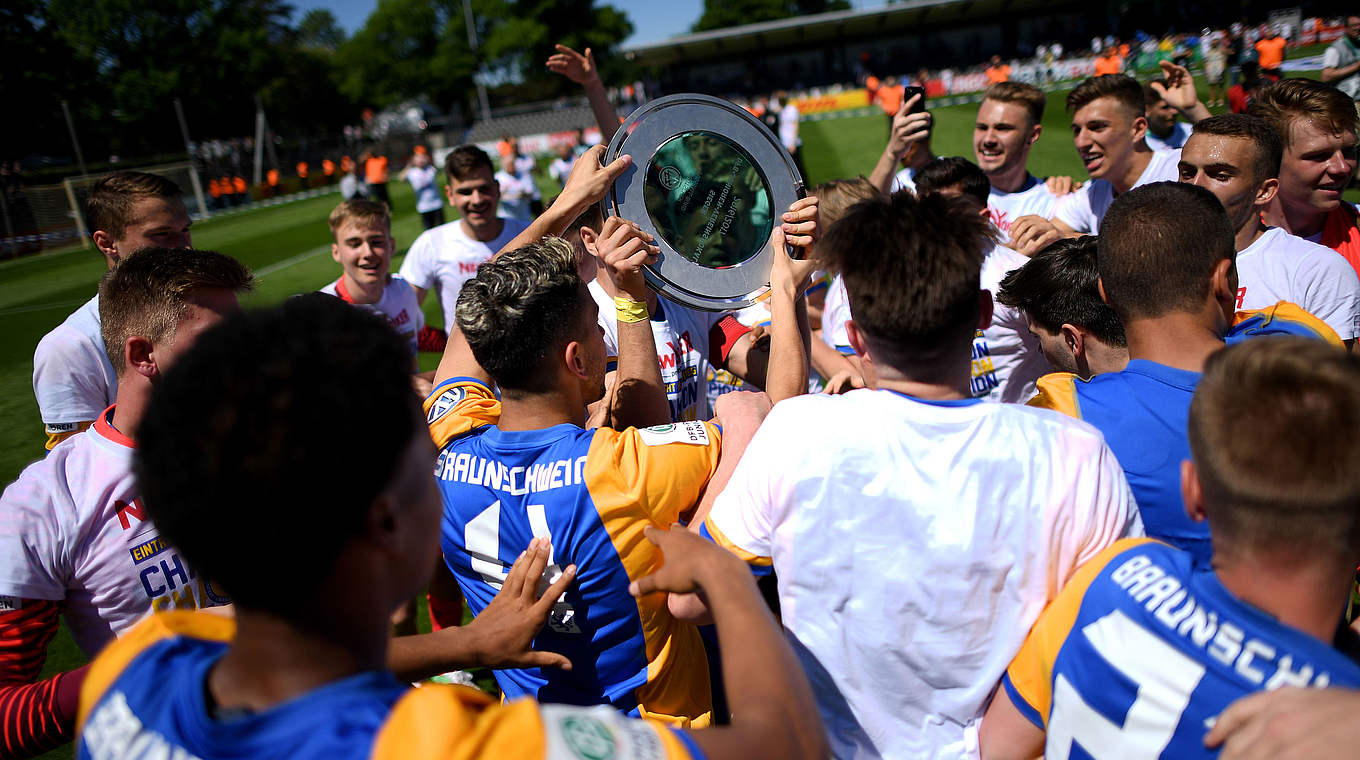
{"left": 373, "top": 684, "right": 699, "bottom": 760}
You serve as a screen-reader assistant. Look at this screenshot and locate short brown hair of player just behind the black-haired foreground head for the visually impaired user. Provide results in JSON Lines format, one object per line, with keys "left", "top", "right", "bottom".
{"left": 99, "top": 247, "right": 254, "bottom": 375}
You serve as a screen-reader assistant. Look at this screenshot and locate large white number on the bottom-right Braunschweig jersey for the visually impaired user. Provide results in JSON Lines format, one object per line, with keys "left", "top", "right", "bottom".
{"left": 1044, "top": 610, "right": 1204, "bottom": 760}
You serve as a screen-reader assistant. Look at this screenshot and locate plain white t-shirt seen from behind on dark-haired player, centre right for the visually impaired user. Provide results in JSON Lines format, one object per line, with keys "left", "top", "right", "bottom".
{"left": 704, "top": 389, "right": 1142, "bottom": 757}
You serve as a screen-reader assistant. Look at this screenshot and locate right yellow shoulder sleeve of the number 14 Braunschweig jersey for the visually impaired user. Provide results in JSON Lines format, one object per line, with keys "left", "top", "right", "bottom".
{"left": 585, "top": 421, "right": 722, "bottom": 525}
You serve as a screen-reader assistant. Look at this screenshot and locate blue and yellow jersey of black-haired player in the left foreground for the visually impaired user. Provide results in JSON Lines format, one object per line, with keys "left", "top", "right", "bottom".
{"left": 76, "top": 612, "right": 703, "bottom": 760}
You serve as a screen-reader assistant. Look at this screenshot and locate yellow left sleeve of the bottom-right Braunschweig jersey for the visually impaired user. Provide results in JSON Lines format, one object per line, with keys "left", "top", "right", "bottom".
{"left": 1006, "top": 538, "right": 1151, "bottom": 727}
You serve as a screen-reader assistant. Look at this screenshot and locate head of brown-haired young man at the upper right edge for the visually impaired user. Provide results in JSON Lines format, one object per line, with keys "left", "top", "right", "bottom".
{"left": 1248, "top": 79, "right": 1360, "bottom": 271}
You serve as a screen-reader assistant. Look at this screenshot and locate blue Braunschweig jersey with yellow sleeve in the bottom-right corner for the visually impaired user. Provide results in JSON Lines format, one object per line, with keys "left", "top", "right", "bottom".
{"left": 1002, "top": 540, "right": 1360, "bottom": 759}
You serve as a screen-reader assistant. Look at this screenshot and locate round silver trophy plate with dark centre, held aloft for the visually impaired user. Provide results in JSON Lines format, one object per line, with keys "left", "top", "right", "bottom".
{"left": 605, "top": 95, "right": 802, "bottom": 311}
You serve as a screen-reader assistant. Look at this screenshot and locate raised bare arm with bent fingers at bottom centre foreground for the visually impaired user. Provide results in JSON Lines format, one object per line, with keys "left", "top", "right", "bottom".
{"left": 630, "top": 526, "right": 830, "bottom": 760}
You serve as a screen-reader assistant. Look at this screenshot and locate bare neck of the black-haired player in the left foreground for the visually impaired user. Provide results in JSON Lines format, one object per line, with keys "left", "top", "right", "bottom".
{"left": 207, "top": 605, "right": 388, "bottom": 712}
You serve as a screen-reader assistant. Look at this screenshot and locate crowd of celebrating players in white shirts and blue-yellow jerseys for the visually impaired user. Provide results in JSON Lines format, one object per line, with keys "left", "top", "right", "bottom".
{"left": 0, "top": 32, "right": 1360, "bottom": 760}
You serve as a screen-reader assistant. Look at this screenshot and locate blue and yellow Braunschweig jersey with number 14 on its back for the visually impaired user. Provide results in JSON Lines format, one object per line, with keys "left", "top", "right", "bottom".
{"left": 426, "top": 378, "right": 719, "bottom": 726}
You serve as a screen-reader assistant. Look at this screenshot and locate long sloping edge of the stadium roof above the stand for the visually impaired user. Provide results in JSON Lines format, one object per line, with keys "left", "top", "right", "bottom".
{"left": 623, "top": 0, "right": 1072, "bottom": 67}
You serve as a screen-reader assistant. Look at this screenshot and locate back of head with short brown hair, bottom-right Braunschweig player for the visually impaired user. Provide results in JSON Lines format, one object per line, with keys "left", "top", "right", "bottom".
{"left": 1187, "top": 337, "right": 1360, "bottom": 555}
